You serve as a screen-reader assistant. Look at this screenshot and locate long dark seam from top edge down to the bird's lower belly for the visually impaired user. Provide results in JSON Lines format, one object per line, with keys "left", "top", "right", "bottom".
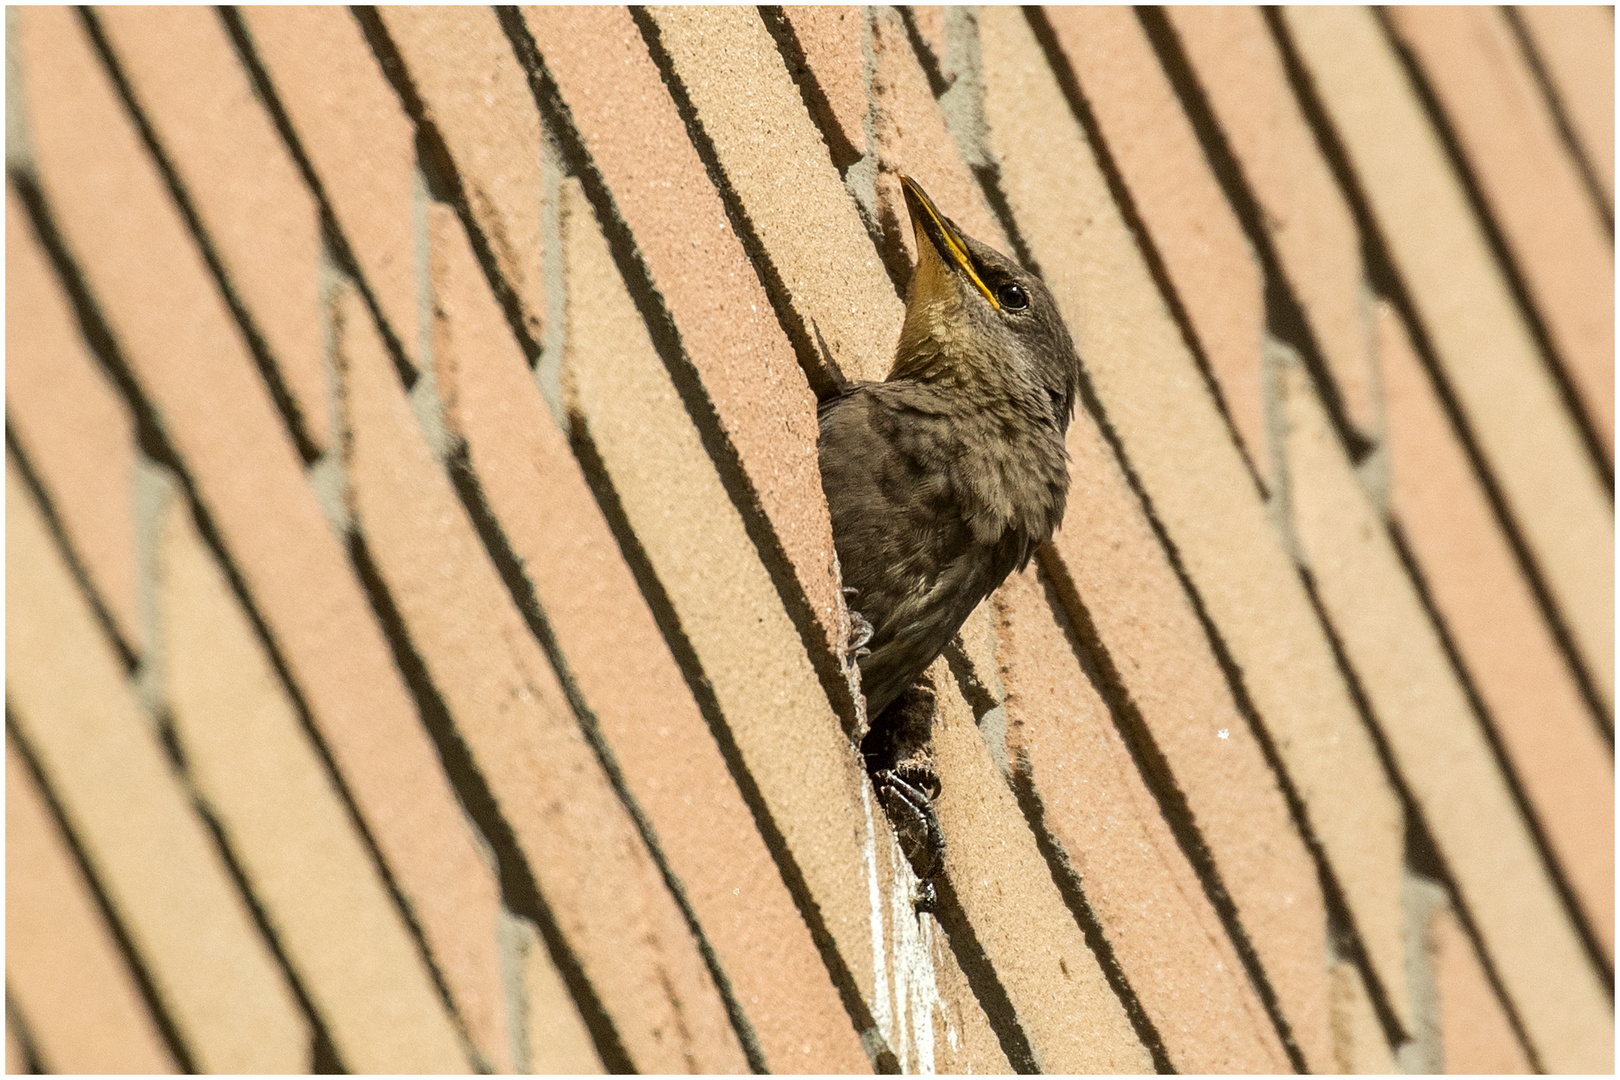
{"left": 499, "top": 8, "right": 859, "bottom": 751}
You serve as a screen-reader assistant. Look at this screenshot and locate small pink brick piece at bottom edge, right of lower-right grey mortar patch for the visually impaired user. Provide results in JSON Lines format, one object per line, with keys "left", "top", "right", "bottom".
{"left": 1429, "top": 910, "right": 1534, "bottom": 1074}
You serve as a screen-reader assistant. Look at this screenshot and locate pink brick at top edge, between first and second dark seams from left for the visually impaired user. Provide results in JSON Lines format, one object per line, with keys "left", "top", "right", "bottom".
{"left": 99, "top": 6, "right": 330, "bottom": 449}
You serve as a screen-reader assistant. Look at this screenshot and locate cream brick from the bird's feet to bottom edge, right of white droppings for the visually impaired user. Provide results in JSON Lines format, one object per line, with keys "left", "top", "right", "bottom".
{"left": 930, "top": 661, "right": 1152, "bottom": 1072}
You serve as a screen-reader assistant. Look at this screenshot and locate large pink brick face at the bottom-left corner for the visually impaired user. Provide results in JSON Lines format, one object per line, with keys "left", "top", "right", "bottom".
{"left": 5, "top": 735, "right": 177, "bottom": 1072}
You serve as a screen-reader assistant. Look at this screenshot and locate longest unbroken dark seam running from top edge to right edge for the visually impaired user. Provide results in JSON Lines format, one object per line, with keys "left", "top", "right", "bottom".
{"left": 1262, "top": 8, "right": 1614, "bottom": 746}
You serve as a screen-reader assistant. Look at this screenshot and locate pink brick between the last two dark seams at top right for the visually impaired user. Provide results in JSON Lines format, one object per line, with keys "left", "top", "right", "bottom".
{"left": 1390, "top": 6, "right": 1615, "bottom": 463}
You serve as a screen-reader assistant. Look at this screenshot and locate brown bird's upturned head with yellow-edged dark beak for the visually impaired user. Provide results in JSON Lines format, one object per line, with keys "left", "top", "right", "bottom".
{"left": 889, "top": 176, "right": 1081, "bottom": 431}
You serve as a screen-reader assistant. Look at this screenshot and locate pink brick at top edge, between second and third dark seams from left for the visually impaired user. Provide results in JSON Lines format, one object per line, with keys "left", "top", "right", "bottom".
{"left": 241, "top": 6, "right": 420, "bottom": 372}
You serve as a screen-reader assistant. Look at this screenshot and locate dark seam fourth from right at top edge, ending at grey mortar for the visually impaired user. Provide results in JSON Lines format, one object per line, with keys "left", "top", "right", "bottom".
{"left": 1136, "top": 6, "right": 1375, "bottom": 465}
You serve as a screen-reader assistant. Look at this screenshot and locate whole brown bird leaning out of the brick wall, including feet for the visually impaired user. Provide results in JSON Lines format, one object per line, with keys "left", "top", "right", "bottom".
{"left": 818, "top": 176, "right": 1081, "bottom": 887}
